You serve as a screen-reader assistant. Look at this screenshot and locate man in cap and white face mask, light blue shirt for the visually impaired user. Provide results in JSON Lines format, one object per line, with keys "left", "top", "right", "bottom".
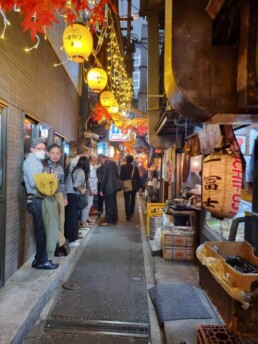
{"left": 23, "top": 139, "right": 59, "bottom": 270}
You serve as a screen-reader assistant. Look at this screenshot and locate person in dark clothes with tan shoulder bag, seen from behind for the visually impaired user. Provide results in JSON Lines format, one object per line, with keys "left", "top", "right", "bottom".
{"left": 120, "top": 154, "right": 141, "bottom": 221}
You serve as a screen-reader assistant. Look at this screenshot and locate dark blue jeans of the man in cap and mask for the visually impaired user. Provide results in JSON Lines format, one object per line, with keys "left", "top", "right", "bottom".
{"left": 27, "top": 196, "right": 48, "bottom": 264}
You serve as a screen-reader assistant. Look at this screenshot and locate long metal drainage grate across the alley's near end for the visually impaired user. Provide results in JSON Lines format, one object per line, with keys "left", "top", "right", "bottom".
{"left": 45, "top": 320, "right": 149, "bottom": 338}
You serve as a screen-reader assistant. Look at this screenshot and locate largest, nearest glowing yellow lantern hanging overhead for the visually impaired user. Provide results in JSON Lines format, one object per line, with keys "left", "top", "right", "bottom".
{"left": 63, "top": 23, "right": 93, "bottom": 63}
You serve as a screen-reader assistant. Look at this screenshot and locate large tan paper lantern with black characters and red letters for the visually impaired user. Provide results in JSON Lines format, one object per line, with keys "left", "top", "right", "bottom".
{"left": 202, "top": 152, "right": 242, "bottom": 218}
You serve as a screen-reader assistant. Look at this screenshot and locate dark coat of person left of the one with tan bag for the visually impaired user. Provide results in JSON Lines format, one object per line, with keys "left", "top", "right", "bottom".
{"left": 100, "top": 160, "right": 121, "bottom": 196}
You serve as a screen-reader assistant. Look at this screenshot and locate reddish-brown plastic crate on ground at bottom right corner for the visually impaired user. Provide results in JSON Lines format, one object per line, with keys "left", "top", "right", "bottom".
{"left": 197, "top": 325, "right": 246, "bottom": 344}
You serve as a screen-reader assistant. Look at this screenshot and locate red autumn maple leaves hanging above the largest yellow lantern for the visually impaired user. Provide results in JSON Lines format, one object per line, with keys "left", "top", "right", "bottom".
{"left": 0, "top": 0, "right": 116, "bottom": 40}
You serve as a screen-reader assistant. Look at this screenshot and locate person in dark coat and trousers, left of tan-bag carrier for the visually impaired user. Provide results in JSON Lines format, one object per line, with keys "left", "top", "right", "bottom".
{"left": 99, "top": 154, "right": 122, "bottom": 226}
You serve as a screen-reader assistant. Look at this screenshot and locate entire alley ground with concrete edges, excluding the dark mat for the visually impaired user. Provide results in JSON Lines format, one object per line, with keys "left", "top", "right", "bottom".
{"left": 0, "top": 193, "right": 227, "bottom": 344}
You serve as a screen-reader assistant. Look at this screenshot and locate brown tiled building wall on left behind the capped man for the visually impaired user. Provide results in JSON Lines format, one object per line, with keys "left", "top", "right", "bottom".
{"left": 0, "top": 13, "right": 80, "bottom": 281}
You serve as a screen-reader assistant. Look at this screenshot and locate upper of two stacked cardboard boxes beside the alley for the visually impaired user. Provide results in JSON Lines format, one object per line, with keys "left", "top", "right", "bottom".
{"left": 162, "top": 227, "right": 194, "bottom": 247}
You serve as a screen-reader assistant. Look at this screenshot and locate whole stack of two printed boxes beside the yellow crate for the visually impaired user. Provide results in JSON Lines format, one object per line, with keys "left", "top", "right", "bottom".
{"left": 161, "top": 226, "right": 195, "bottom": 261}
